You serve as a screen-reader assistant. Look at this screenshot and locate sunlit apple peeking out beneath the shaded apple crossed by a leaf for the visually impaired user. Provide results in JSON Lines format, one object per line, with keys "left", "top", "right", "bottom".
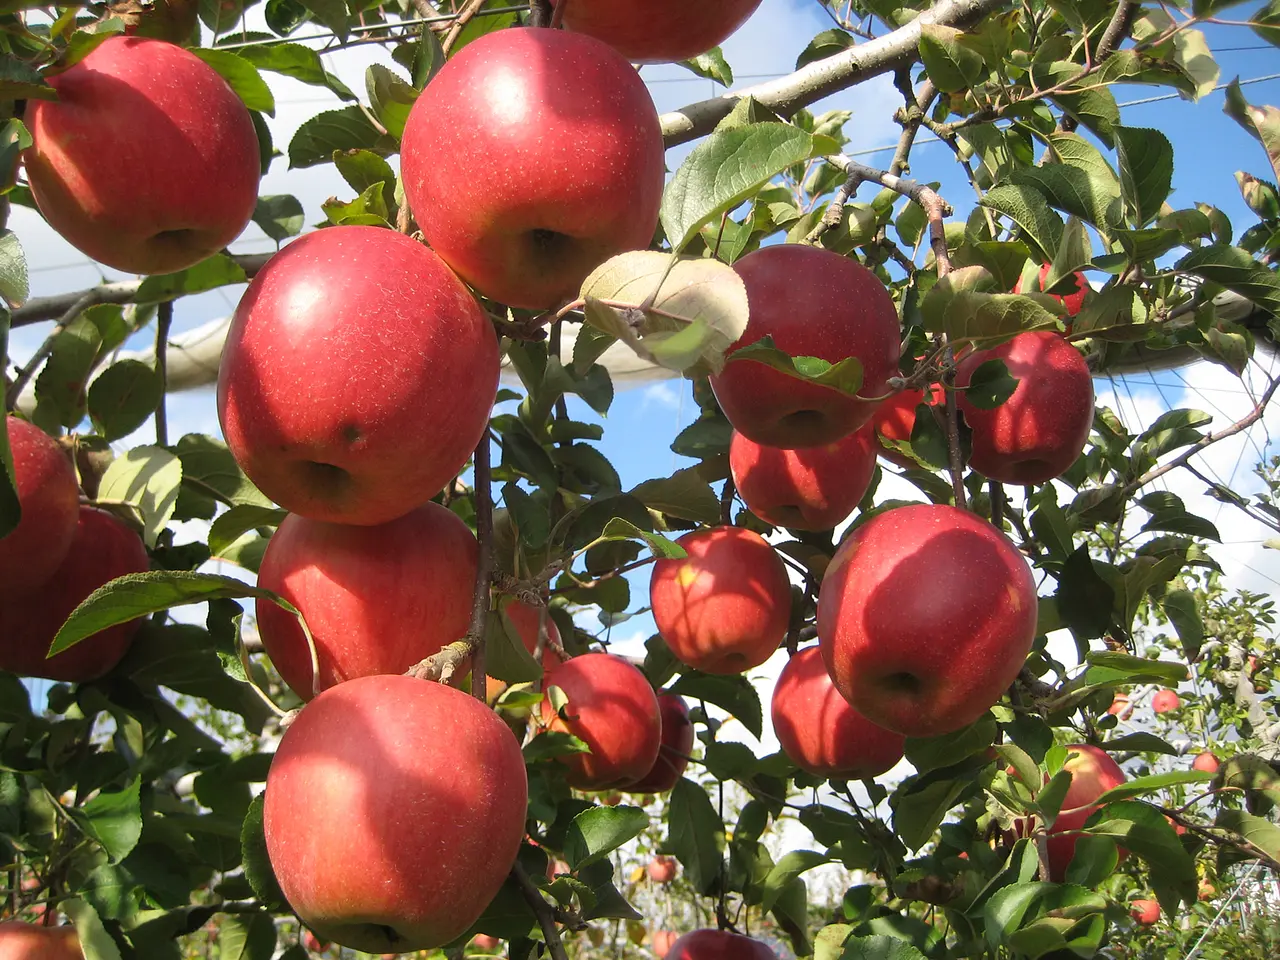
{"left": 728, "top": 426, "right": 879, "bottom": 530}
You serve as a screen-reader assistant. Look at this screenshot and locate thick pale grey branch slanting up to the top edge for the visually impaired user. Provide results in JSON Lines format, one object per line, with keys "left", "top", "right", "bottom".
{"left": 660, "top": 0, "right": 1007, "bottom": 147}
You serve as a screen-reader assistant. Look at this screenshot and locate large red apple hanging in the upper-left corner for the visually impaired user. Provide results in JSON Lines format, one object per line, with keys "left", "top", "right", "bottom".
{"left": 24, "top": 37, "right": 261, "bottom": 274}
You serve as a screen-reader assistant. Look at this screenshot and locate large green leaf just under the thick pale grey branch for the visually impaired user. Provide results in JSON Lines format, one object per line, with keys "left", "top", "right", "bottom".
{"left": 662, "top": 122, "right": 838, "bottom": 252}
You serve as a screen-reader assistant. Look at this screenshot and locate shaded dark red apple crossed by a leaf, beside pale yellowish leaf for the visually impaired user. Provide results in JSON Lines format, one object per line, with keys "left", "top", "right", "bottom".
{"left": 710, "top": 243, "right": 901, "bottom": 448}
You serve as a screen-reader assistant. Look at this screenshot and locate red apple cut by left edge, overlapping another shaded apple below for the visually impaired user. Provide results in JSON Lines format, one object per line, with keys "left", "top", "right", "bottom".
{"left": 0, "top": 416, "right": 79, "bottom": 600}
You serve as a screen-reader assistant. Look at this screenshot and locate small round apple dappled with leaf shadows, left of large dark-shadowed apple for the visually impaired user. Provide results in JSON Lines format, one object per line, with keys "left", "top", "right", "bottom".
{"left": 649, "top": 526, "right": 791, "bottom": 673}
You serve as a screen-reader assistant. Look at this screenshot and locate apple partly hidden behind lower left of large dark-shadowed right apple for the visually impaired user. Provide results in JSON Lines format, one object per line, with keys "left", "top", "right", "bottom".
{"left": 772, "top": 646, "right": 906, "bottom": 780}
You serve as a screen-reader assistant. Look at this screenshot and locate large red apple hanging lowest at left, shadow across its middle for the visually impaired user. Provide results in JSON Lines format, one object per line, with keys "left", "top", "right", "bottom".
{"left": 262, "top": 676, "right": 529, "bottom": 954}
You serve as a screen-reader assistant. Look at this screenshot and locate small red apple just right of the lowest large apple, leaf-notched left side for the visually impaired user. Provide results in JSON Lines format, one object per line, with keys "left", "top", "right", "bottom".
{"left": 541, "top": 653, "right": 662, "bottom": 790}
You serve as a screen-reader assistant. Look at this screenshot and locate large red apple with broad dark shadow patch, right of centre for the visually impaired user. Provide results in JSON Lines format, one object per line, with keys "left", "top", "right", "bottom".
{"left": 818, "top": 504, "right": 1038, "bottom": 737}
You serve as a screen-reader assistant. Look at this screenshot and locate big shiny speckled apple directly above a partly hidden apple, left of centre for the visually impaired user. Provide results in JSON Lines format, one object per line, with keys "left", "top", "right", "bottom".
{"left": 218, "top": 227, "right": 498, "bottom": 526}
